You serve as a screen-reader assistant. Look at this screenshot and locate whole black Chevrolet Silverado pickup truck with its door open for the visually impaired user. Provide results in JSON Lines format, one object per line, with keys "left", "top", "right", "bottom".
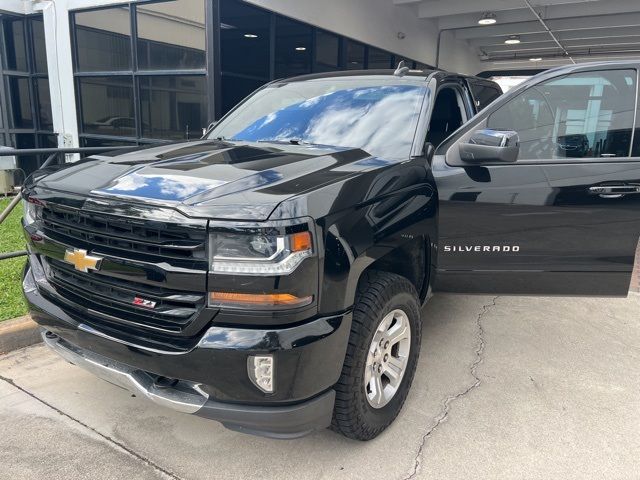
{"left": 23, "top": 63, "right": 640, "bottom": 440}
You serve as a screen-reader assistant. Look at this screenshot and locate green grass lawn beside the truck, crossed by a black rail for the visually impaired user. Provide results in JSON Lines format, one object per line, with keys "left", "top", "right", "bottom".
{"left": 0, "top": 198, "right": 27, "bottom": 321}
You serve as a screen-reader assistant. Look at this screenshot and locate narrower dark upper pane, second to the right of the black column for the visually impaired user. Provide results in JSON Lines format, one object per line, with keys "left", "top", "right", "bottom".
{"left": 275, "top": 17, "right": 312, "bottom": 78}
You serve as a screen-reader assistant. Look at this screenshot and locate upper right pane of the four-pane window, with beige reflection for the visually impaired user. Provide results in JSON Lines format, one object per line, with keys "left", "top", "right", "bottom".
{"left": 136, "top": 0, "right": 206, "bottom": 70}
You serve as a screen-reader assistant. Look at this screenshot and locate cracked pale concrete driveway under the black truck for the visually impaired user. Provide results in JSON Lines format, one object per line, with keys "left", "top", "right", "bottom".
{"left": 0, "top": 294, "right": 640, "bottom": 480}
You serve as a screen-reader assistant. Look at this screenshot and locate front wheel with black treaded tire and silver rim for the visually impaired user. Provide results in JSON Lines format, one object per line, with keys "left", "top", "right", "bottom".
{"left": 331, "top": 271, "right": 421, "bottom": 440}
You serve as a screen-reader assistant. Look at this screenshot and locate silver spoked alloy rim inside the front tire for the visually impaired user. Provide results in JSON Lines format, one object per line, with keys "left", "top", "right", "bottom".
{"left": 364, "top": 310, "right": 411, "bottom": 408}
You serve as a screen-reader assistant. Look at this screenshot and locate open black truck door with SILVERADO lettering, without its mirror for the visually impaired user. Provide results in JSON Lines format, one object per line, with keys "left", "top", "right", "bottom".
{"left": 433, "top": 65, "right": 640, "bottom": 295}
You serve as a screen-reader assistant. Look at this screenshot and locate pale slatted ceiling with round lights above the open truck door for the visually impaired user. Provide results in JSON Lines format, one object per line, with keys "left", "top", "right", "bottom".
{"left": 389, "top": 0, "right": 640, "bottom": 70}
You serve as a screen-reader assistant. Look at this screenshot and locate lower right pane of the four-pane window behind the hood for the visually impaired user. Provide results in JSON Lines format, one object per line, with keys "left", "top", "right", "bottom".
{"left": 140, "top": 75, "right": 207, "bottom": 140}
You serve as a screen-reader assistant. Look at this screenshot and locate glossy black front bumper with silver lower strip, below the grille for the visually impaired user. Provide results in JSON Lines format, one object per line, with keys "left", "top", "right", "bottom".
{"left": 23, "top": 269, "right": 351, "bottom": 438}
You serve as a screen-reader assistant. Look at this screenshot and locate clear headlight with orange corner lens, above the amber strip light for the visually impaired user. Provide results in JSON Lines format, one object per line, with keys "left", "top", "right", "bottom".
{"left": 210, "top": 229, "right": 313, "bottom": 276}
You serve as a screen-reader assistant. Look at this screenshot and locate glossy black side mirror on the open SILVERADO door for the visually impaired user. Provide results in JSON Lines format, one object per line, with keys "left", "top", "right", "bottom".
{"left": 458, "top": 130, "right": 520, "bottom": 164}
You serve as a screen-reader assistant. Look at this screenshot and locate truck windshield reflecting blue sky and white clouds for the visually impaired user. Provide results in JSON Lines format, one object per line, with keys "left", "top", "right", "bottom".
{"left": 208, "top": 78, "right": 428, "bottom": 159}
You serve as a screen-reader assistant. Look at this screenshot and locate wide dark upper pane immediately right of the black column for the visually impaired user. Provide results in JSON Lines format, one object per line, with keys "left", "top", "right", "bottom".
{"left": 220, "top": 1, "right": 271, "bottom": 78}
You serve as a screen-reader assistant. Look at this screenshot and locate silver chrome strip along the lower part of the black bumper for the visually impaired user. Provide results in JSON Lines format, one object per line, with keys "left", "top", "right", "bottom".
{"left": 42, "top": 329, "right": 209, "bottom": 413}
